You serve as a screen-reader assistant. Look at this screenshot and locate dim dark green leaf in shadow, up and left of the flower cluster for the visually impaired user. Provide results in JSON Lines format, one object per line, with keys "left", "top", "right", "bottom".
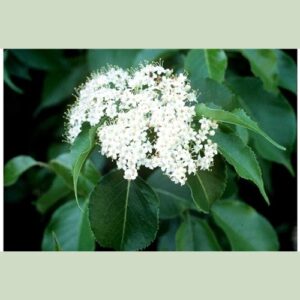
{"left": 36, "top": 65, "right": 86, "bottom": 113}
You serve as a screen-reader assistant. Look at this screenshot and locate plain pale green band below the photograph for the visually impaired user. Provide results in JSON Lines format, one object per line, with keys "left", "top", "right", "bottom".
{"left": 0, "top": 252, "right": 300, "bottom": 300}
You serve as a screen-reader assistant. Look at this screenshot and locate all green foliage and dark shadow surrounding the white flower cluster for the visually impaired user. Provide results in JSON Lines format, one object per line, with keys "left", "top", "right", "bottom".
{"left": 4, "top": 49, "right": 297, "bottom": 251}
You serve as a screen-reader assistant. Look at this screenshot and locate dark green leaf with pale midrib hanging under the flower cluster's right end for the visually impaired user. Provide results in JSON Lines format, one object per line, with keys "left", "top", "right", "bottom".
{"left": 187, "top": 156, "right": 227, "bottom": 213}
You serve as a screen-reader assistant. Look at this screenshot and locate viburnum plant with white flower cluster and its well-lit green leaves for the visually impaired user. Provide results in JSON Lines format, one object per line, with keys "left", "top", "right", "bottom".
{"left": 5, "top": 50, "right": 295, "bottom": 251}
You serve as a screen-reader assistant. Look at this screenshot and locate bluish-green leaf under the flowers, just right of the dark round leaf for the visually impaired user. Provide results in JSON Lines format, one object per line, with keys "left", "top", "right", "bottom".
{"left": 147, "top": 169, "right": 195, "bottom": 219}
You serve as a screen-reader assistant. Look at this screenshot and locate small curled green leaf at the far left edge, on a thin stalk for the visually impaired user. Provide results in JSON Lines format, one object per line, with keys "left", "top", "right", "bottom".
{"left": 4, "top": 155, "right": 39, "bottom": 186}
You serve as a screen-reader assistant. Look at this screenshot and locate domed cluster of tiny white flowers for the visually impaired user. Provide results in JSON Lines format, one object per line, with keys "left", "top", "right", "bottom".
{"left": 67, "top": 64, "right": 218, "bottom": 185}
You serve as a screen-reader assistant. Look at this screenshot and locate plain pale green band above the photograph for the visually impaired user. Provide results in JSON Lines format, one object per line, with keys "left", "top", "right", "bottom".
{"left": 0, "top": 0, "right": 300, "bottom": 48}
